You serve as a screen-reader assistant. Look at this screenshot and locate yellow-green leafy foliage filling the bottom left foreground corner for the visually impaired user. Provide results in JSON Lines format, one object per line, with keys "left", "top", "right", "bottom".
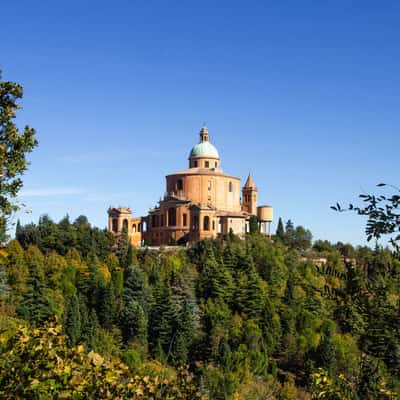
{"left": 0, "top": 323, "right": 205, "bottom": 400}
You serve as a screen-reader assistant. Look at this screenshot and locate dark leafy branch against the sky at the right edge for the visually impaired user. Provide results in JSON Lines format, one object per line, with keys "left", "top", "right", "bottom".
{"left": 331, "top": 183, "right": 400, "bottom": 251}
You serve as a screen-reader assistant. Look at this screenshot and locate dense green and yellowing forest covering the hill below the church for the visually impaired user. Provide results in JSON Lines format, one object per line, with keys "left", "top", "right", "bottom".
{"left": 0, "top": 216, "right": 400, "bottom": 400}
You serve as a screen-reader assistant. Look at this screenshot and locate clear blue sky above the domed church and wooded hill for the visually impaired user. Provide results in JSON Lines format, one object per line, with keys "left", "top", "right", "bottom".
{"left": 0, "top": 0, "right": 400, "bottom": 244}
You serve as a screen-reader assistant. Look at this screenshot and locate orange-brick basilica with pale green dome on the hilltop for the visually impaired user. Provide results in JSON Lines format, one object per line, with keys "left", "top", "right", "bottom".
{"left": 108, "top": 127, "right": 273, "bottom": 246}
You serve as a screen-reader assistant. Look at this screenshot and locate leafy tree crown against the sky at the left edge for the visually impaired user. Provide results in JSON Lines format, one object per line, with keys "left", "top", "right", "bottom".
{"left": 0, "top": 70, "right": 38, "bottom": 242}
